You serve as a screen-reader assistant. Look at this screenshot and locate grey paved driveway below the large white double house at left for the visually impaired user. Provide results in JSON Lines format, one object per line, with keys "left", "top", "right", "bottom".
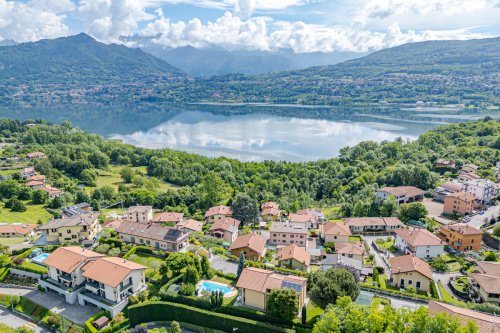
{"left": 0, "top": 288, "right": 99, "bottom": 325}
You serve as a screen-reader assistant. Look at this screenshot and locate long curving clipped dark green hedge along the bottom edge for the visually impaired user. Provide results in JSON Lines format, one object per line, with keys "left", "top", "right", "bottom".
{"left": 129, "top": 302, "right": 294, "bottom": 333}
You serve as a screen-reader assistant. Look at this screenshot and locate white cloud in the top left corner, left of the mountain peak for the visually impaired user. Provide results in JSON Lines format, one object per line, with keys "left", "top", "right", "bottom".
{"left": 0, "top": 0, "right": 69, "bottom": 42}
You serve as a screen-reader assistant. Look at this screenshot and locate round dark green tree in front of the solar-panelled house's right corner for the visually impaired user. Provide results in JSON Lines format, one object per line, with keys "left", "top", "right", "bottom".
{"left": 267, "top": 288, "right": 299, "bottom": 321}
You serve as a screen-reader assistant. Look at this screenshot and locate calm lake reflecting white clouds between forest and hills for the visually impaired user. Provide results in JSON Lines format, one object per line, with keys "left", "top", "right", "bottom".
{"left": 0, "top": 104, "right": 500, "bottom": 162}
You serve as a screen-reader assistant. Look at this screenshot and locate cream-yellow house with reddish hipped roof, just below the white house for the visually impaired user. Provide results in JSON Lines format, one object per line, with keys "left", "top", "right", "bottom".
{"left": 390, "top": 254, "right": 432, "bottom": 291}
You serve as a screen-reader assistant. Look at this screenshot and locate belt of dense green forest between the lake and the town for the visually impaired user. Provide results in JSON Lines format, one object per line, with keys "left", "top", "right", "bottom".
{"left": 0, "top": 118, "right": 500, "bottom": 217}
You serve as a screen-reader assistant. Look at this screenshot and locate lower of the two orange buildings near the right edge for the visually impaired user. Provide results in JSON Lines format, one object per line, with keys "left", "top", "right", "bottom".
{"left": 437, "top": 223, "right": 483, "bottom": 252}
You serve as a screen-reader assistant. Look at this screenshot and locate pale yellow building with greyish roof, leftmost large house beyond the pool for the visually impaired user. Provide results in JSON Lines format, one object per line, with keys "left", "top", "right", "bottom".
{"left": 38, "top": 212, "right": 101, "bottom": 243}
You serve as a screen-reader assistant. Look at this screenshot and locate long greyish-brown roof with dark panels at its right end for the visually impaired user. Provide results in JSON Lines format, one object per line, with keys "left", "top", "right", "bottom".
{"left": 116, "top": 221, "right": 189, "bottom": 242}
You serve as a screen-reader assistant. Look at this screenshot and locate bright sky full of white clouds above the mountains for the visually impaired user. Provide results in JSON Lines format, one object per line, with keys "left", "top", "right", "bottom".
{"left": 0, "top": 0, "right": 500, "bottom": 53}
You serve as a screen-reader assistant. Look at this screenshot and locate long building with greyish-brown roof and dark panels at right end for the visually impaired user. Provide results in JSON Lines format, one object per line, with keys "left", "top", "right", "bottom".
{"left": 116, "top": 221, "right": 191, "bottom": 252}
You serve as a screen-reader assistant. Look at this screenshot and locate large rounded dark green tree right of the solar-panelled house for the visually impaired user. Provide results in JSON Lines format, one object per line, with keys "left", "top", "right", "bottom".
{"left": 309, "top": 268, "right": 359, "bottom": 309}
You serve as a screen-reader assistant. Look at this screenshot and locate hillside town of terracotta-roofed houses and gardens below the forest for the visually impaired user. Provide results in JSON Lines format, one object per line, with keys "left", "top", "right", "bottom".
{"left": 0, "top": 120, "right": 500, "bottom": 333}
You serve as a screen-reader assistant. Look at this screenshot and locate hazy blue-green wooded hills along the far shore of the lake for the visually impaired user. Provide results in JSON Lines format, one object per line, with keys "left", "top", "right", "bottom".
{"left": 0, "top": 34, "right": 500, "bottom": 107}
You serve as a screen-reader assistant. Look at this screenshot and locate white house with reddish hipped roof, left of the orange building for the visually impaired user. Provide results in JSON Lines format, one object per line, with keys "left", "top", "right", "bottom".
{"left": 394, "top": 228, "right": 446, "bottom": 259}
